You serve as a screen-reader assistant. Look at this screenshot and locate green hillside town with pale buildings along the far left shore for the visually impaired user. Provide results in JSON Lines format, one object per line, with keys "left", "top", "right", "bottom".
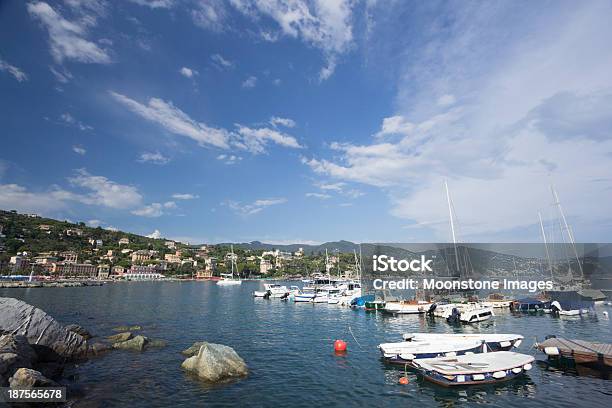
{"left": 0, "top": 211, "right": 351, "bottom": 280}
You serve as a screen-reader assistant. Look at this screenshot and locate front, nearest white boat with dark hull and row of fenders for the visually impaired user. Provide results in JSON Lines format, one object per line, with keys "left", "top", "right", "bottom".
{"left": 412, "top": 351, "right": 535, "bottom": 387}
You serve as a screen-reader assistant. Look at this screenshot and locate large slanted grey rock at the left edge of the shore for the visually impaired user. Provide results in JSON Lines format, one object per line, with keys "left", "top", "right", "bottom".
{"left": 0, "top": 297, "right": 88, "bottom": 360}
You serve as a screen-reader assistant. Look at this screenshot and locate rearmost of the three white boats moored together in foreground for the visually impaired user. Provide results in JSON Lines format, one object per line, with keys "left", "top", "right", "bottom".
{"left": 402, "top": 333, "right": 523, "bottom": 351}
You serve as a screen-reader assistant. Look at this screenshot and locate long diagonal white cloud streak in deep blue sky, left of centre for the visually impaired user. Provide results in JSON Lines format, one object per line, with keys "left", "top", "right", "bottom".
{"left": 110, "top": 91, "right": 229, "bottom": 149}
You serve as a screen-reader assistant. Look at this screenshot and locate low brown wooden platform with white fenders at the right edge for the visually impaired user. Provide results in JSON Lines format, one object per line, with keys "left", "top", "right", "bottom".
{"left": 537, "top": 337, "right": 612, "bottom": 367}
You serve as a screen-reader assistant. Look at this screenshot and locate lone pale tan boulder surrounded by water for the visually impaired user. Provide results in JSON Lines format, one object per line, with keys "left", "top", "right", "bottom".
{"left": 181, "top": 343, "right": 249, "bottom": 383}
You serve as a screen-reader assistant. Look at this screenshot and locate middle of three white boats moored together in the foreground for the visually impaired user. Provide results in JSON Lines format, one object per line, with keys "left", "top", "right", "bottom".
{"left": 378, "top": 338, "right": 486, "bottom": 364}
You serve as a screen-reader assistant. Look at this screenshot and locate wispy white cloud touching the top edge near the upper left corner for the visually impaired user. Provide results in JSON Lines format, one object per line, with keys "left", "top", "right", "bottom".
{"left": 27, "top": 2, "right": 111, "bottom": 64}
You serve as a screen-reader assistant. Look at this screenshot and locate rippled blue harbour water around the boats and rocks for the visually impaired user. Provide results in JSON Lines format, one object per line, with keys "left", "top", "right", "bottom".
{"left": 0, "top": 282, "right": 612, "bottom": 408}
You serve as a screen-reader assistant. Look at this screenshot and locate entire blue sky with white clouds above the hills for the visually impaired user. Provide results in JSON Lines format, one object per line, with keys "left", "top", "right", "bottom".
{"left": 0, "top": 0, "right": 612, "bottom": 243}
